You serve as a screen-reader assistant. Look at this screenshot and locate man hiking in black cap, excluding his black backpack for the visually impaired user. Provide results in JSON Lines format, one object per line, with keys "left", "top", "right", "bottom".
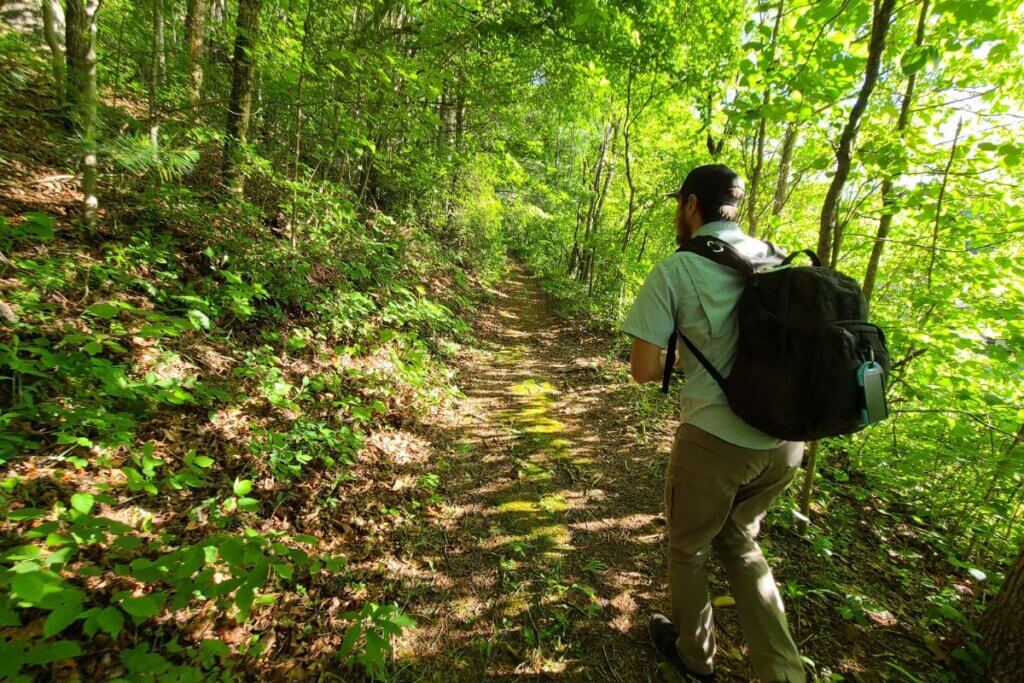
{"left": 623, "top": 165, "right": 806, "bottom": 683}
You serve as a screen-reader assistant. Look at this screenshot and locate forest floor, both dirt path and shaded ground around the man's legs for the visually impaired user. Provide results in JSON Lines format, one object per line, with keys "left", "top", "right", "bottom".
{"left": 396, "top": 269, "right": 951, "bottom": 681}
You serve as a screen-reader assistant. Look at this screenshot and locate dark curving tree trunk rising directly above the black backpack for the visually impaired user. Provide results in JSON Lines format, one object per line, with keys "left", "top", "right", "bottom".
{"left": 810, "top": 0, "right": 896, "bottom": 270}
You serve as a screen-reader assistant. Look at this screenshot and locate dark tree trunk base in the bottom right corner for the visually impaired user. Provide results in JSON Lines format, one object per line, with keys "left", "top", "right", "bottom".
{"left": 979, "top": 547, "right": 1024, "bottom": 683}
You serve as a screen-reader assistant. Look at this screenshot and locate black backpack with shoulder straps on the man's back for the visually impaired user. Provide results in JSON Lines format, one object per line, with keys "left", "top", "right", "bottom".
{"left": 662, "top": 237, "right": 889, "bottom": 441}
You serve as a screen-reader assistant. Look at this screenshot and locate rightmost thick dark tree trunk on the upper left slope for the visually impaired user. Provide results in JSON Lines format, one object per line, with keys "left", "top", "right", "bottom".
{"left": 222, "top": 0, "right": 263, "bottom": 195}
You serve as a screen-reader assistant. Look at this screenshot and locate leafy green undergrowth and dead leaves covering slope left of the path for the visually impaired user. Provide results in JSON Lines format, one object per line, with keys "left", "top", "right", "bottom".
{"left": 0, "top": 181, "right": 495, "bottom": 680}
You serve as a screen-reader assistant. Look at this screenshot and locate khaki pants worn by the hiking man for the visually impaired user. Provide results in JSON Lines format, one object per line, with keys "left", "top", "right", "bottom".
{"left": 665, "top": 424, "right": 805, "bottom": 683}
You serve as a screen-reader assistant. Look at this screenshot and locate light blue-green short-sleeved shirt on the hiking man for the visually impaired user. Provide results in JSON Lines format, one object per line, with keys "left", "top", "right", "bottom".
{"left": 623, "top": 221, "right": 782, "bottom": 450}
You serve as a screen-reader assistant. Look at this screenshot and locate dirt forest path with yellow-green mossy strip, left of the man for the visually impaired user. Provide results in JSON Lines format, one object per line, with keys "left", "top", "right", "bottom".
{"left": 399, "top": 270, "right": 745, "bottom": 681}
